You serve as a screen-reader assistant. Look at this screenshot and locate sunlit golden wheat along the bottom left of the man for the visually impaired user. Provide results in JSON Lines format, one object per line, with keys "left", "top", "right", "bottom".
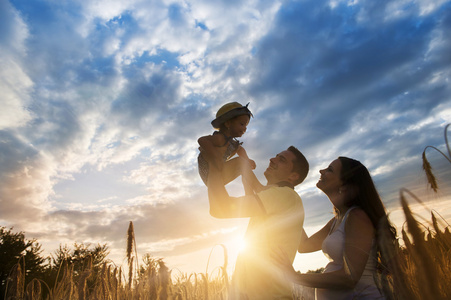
{"left": 5, "top": 222, "right": 233, "bottom": 300}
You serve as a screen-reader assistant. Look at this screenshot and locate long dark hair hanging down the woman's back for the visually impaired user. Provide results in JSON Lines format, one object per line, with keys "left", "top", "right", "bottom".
{"left": 338, "top": 157, "right": 397, "bottom": 278}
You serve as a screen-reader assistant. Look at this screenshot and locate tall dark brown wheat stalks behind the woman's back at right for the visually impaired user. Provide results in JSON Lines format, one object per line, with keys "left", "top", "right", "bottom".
{"left": 381, "top": 189, "right": 451, "bottom": 300}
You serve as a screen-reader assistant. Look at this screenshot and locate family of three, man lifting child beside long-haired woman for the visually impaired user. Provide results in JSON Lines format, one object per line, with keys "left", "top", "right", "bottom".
{"left": 198, "top": 102, "right": 395, "bottom": 300}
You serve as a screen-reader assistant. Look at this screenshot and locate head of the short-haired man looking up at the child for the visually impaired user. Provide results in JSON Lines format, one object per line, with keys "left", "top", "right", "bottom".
{"left": 265, "top": 146, "right": 309, "bottom": 186}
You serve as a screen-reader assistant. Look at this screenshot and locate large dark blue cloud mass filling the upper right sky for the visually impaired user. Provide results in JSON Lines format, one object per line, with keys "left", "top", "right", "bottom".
{"left": 247, "top": 1, "right": 450, "bottom": 149}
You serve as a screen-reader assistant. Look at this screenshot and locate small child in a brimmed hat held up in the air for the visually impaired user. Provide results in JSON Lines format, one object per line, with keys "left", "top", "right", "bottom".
{"left": 197, "top": 102, "right": 262, "bottom": 190}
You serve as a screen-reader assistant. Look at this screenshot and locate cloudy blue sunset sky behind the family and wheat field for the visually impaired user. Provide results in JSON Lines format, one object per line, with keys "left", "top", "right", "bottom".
{"left": 0, "top": 0, "right": 451, "bottom": 274}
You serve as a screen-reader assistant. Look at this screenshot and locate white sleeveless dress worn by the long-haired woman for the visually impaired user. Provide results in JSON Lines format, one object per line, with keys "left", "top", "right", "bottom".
{"left": 315, "top": 206, "right": 385, "bottom": 300}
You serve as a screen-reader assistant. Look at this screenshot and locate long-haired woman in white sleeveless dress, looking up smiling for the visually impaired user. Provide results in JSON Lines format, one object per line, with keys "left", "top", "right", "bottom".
{"left": 276, "top": 157, "right": 396, "bottom": 300}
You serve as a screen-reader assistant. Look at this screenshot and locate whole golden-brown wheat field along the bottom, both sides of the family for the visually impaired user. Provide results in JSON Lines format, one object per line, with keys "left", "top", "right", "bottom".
{"left": 6, "top": 203, "right": 451, "bottom": 300}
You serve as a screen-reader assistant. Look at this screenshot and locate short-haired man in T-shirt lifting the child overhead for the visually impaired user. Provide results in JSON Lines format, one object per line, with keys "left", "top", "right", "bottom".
{"left": 208, "top": 146, "right": 309, "bottom": 300}
